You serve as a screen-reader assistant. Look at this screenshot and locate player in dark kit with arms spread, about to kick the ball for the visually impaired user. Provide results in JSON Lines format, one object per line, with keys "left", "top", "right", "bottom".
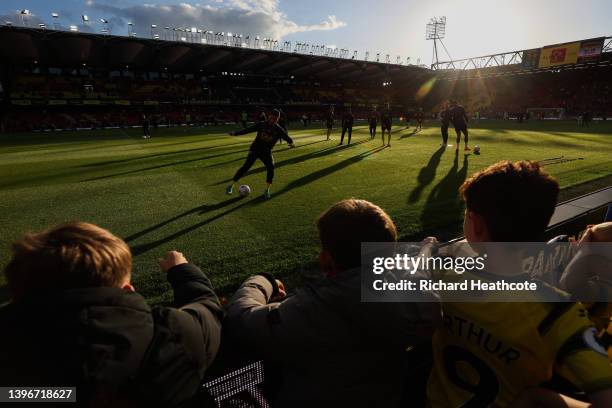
{"left": 225, "top": 109, "right": 295, "bottom": 198}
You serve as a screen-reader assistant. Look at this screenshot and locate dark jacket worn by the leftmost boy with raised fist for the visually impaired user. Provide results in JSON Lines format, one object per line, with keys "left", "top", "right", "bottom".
{"left": 0, "top": 264, "right": 222, "bottom": 407}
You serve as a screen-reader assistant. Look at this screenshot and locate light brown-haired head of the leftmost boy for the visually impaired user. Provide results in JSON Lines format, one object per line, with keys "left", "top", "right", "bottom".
{"left": 4, "top": 222, "right": 134, "bottom": 300}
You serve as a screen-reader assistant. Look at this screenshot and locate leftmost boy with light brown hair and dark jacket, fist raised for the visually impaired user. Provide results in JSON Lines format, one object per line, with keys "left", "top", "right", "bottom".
{"left": 0, "top": 222, "right": 222, "bottom": 407}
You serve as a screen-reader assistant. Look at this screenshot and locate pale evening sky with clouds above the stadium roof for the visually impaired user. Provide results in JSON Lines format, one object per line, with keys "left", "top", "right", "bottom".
{"left": 0, "top": 0, "right": 612, "bottom": 64}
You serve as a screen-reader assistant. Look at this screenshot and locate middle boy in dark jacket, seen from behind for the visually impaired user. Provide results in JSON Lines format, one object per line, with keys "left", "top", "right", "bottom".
{"left": 224, "top": 199, "right": 439, "bottom": 407}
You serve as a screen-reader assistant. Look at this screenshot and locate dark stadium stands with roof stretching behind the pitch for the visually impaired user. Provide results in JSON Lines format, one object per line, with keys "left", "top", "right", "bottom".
{"left": 0, "top": 26, "right": 612, "bottom": 131}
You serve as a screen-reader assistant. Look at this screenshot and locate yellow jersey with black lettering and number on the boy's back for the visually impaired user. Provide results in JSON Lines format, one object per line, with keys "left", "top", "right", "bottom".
{"left": 427, "top": 276, "right": 612, "bottom": 408}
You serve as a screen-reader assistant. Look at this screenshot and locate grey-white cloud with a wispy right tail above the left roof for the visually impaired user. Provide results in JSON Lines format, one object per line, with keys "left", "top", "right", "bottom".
{"left": 90, "top": 0, "right": 346, "bottom": 39}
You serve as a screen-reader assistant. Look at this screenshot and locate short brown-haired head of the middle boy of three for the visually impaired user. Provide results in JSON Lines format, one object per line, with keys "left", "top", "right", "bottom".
{"left": 317, "top": 199, "right": 397, "bottom": 276}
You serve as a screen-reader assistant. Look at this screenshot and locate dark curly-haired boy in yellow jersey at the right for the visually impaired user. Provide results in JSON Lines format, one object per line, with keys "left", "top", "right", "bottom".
{"left": 428, "top": 161, "right": 612, "bottom": 407}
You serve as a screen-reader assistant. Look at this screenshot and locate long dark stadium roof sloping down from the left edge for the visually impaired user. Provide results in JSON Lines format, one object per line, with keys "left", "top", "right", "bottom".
{"left": 0, "top": 26, "right": 432, "bottom": 84}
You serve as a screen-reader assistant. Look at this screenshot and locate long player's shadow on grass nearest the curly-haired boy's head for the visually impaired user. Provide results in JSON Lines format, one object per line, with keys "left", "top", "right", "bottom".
{"left": 421, "top": 151, "right": 469, "bottom": 230}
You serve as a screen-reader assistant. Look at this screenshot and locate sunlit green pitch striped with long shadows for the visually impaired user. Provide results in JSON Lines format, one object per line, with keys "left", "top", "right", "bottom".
{"left": 0, "top": 121, "right": 612, "bottom": 302}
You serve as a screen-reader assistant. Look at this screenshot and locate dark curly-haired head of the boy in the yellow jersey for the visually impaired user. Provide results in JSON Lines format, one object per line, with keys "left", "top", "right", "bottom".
{"left": 460, "top": 161, "right": 559, "bottom": 242}
